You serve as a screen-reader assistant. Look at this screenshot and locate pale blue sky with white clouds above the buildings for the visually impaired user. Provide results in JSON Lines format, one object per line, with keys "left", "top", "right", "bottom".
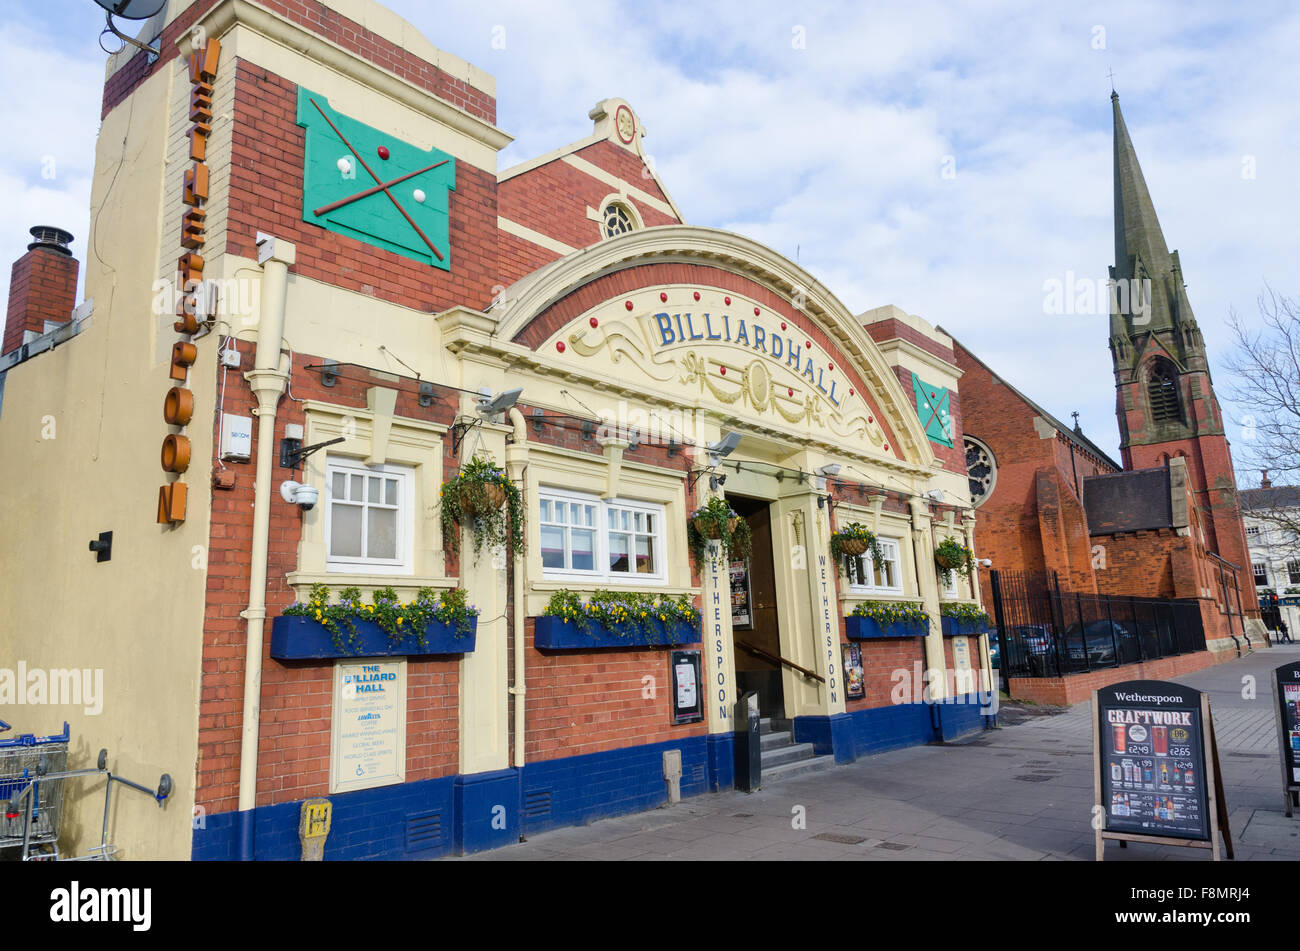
{"left": 0, "top": 0, "right": 1300, "bottom": 472}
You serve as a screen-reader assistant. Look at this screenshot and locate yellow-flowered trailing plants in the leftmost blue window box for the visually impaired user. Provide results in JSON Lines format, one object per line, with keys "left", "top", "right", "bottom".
{"left": 282, "top": 585, "right": 478, "bottom": 653}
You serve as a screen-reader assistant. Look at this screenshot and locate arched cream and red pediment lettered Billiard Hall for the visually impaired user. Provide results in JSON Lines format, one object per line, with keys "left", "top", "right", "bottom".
{"left": 490, "top": 225, "right": 936, "bottom": 470}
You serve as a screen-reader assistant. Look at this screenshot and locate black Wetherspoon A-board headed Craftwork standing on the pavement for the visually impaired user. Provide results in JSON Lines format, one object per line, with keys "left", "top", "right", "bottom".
{"left": 1093, "top": 681, "right": 1232, "bottom": 860}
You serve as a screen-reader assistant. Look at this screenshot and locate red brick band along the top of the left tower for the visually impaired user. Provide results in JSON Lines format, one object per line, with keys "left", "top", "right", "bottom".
{"left": 100, "top": 0, "right": 497, "bottom": 125}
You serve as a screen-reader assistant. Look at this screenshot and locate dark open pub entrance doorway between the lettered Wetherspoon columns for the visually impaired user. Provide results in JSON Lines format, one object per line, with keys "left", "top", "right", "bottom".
{"left": 727, "top": 495, "right": 785, "bottom": 720}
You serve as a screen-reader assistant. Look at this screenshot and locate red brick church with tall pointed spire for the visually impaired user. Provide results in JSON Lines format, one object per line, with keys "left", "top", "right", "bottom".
{"left": 954, "top": 94, "right": 1264, "bottom": 659}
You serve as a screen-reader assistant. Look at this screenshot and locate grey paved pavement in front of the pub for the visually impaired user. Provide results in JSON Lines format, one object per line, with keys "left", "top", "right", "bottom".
{"left": 442, "top": 646, "right": 1300, "bottom": 861}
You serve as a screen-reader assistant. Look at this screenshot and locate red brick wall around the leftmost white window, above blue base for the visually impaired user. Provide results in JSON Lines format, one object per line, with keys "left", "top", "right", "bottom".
{"left": 196, "top": 343, "right": 459, "bottom": 812}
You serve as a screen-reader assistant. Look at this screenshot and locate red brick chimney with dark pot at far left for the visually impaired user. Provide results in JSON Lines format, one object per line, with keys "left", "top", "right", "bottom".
{"left": 0, "top": 225, "right": 79, "bottom": 355}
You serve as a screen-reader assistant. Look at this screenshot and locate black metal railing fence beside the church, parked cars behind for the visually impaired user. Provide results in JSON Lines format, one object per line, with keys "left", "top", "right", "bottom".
{"left": 989, "top": 572, "right": 1205, "bottom": 681}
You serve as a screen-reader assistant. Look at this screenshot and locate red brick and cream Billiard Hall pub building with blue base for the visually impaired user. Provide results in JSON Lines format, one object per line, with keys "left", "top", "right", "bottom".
{"left": 0, "top": 0, "right": 992, "bottom": 859}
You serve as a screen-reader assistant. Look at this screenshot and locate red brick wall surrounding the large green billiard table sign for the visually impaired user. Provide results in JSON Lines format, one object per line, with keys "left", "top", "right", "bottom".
{"left": 226, "top": 60, "right": 502, "bottom": 312}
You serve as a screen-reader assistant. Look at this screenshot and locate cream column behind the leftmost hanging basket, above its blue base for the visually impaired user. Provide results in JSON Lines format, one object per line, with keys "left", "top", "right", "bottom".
{"left": 459, "top": 394, "right": 512, "bottom": 774}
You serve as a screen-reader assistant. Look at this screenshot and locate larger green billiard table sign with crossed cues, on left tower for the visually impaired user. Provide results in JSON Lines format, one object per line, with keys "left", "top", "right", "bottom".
{"left": 298, "top": 87, "right": 456, "bottom": 270}
